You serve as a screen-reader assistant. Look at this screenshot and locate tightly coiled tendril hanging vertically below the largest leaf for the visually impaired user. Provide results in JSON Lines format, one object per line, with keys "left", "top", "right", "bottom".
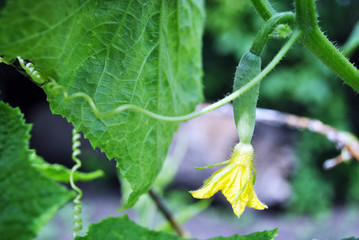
{"left": 70, "top": 129, "right": 82, "bottom": 238}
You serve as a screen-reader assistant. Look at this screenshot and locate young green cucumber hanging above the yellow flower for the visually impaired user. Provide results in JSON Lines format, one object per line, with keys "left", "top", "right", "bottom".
{"left": 233, "top": 51, "right": 261, "bottom": 144}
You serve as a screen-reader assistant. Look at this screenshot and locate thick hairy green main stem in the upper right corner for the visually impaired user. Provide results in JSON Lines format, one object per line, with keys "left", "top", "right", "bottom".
{"left": 295, "top": 0, "right": 359, "bottom": 92}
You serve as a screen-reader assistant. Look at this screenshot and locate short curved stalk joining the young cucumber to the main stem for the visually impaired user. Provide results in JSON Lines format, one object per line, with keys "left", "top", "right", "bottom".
{"left": 250, "top": 12, "right": 295, "bottom": 56}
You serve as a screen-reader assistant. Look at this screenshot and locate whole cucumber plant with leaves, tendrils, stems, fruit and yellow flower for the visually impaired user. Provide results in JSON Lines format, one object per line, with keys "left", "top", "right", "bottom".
{"left": 0, "top": 0, "right": 359, "bottom": 239}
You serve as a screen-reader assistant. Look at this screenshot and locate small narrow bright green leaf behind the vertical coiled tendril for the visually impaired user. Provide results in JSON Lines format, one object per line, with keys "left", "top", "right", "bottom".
{"left": 31, "top": 151, "right": 105, "bottom": 183}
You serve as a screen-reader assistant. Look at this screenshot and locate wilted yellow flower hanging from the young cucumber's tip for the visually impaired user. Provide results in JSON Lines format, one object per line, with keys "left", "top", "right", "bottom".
{"left": 190, "top": 143, "right": 268, "bottom": 217}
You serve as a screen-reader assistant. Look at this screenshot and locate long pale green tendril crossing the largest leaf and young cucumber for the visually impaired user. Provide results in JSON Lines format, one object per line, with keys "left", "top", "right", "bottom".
{"left": 45, "top": 30, "right": 301, "bottom": 122}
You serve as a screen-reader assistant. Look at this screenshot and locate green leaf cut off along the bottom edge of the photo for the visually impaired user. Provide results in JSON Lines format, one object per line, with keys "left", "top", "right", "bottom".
{"left": 75, "top": 215, "right": 277, "bottom": 240}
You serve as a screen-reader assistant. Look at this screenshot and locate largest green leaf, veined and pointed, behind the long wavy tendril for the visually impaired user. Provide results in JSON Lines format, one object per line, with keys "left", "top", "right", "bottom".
{"left": 0, "top": 0, "right": 204, "bottom": 206}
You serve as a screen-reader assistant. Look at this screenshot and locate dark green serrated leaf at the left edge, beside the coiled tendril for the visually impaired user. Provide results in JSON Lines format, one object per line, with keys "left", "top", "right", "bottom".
{"left": 0, "top": 102, "right": 73, "bottom": 240}
